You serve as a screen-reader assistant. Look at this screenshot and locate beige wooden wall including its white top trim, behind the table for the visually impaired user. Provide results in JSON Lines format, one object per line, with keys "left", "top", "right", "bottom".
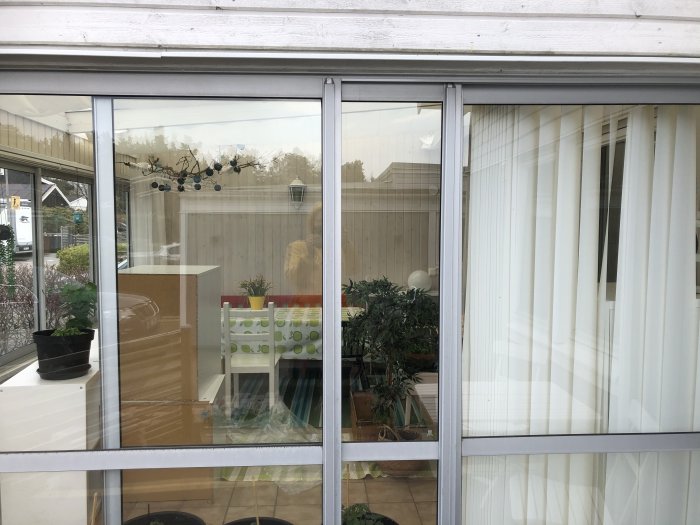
{"left": 142, "top": 189, "right": 440, "bottom": 295}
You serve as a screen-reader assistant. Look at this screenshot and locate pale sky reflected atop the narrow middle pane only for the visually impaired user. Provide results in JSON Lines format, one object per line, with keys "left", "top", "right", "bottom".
{"left": 342, "top": 102, "right": 442, "bottom": 178}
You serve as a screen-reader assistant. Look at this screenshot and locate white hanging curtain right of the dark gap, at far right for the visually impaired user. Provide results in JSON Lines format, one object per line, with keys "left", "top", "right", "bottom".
{"left": 606, "top": 106, "right": 700, "bottom": 523}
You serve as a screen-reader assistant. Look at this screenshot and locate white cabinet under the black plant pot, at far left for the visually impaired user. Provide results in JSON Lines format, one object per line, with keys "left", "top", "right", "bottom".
{"left": 0, "top": 346, "right": 102, "bottom": 525}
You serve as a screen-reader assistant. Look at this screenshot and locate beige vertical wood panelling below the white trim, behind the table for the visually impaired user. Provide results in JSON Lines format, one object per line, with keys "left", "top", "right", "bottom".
{"left": 171, "top": 205, "right": 439, "bottom": 295}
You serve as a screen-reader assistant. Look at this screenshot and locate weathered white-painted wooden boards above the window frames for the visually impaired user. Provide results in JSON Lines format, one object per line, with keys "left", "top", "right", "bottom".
{"left": 0, "top": 0, "right": 700, "bottom": 57}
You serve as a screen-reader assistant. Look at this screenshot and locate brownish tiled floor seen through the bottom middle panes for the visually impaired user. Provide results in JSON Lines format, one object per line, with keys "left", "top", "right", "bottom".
{"left": 123, "top": 477, "right": 437, "bottom": 525}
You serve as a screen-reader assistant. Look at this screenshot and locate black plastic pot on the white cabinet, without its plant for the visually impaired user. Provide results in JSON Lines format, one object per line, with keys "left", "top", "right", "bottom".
{"left": 32, "top": 330, "right": 95, "bottom": 379}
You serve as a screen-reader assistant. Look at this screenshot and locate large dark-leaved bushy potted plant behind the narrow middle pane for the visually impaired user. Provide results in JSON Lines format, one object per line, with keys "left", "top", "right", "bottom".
{"left": 343, "top": 277, "right": 439, "bottom": 441}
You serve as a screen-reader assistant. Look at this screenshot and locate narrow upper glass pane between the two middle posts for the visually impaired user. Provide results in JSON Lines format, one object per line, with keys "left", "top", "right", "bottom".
{"left": 341, "top": 102, "right": 442, "bottom": 441}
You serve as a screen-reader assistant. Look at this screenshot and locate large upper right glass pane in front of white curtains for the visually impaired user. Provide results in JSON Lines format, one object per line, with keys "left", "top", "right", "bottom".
{"left": 463, "top": 105, "right": 700, "bottom": 436}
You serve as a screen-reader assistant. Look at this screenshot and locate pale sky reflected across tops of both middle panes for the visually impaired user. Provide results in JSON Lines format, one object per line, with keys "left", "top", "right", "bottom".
{"left": 114, "top": 99, "right": 442, "bottom": 178}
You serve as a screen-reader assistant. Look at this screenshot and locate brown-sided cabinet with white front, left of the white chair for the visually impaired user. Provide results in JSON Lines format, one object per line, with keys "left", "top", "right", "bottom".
{"left": 118, "top": 265, "right": 224, "bottom": 502}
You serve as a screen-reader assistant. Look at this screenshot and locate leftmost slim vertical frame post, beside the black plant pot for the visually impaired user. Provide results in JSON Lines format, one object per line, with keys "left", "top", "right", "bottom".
{"left": 93, "top": 97, "right": 122, "bottom": 524}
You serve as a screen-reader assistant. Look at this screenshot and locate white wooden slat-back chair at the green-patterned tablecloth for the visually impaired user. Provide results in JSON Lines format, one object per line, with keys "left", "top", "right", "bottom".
{"left": 221, "top": 303, "right": 280, "bottom": 416}
